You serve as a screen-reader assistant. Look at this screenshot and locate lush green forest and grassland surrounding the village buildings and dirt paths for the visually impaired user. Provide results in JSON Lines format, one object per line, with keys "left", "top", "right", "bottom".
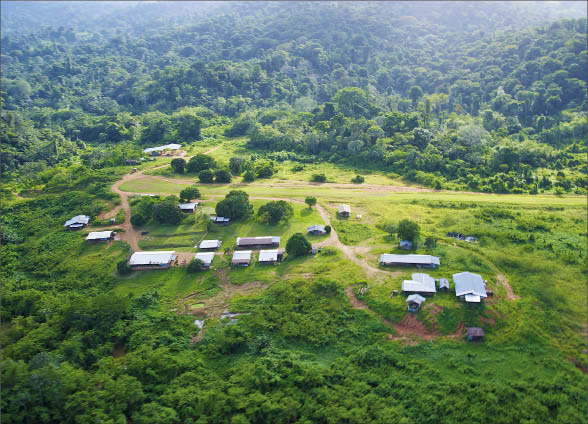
{"left": 0, "top": 2, "right": 588, "bottom": 424}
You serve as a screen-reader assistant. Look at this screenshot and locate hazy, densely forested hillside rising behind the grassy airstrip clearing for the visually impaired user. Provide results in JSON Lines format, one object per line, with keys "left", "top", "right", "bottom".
{"left": 2, "top": 2, "right": 586, "bottom": 192}
